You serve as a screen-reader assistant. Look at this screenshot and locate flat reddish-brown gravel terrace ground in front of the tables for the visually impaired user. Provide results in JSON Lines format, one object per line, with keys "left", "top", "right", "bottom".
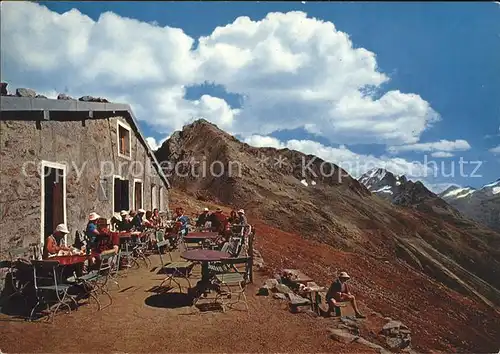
{"left": 0, "top": 256, "right": 369, "bottom": 353}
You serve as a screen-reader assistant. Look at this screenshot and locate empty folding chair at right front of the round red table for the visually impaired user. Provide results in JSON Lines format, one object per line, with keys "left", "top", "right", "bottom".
{"left": 215, "top": 257, "right": 250, "bottom": 312}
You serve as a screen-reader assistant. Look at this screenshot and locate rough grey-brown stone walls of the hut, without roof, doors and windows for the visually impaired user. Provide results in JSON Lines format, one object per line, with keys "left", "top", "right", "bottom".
{"left": 0, "top": 113, "right": 168, "bottom": 256}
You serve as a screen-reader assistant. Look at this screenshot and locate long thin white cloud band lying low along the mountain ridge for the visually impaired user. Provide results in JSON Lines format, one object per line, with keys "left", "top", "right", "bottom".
{"left": 244, "top": 135, "right": 434, "bottom": 178}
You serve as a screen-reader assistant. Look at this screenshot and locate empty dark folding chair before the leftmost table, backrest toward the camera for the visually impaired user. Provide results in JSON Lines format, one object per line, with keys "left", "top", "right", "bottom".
{"left": 29, "top": 260, "right": 78, "bottom": 321}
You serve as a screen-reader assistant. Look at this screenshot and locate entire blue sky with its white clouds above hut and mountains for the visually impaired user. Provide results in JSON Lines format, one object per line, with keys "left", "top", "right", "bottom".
{"left": 2, "top": 2, "right": 500, "bottom": 188}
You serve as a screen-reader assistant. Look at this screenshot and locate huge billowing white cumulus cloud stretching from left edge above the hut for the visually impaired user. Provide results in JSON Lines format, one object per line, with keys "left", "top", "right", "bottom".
{"left": 1, "top": 2, "right": 445, "bottom": 145}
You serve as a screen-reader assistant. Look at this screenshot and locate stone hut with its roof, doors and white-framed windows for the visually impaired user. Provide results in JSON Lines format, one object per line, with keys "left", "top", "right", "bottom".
{"left": 0, "top": 96, "right": 170, "bottom": 257}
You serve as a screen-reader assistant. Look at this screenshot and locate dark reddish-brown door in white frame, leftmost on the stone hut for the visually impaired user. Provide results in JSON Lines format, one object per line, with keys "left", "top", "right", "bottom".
{"left": 44, "top": 166, "right": 64, "bottom": 240}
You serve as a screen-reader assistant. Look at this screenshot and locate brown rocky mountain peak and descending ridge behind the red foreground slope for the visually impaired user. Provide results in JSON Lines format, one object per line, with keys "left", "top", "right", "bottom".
{"left": 157, "top": 120, "right": 500, "bottom": 306}
